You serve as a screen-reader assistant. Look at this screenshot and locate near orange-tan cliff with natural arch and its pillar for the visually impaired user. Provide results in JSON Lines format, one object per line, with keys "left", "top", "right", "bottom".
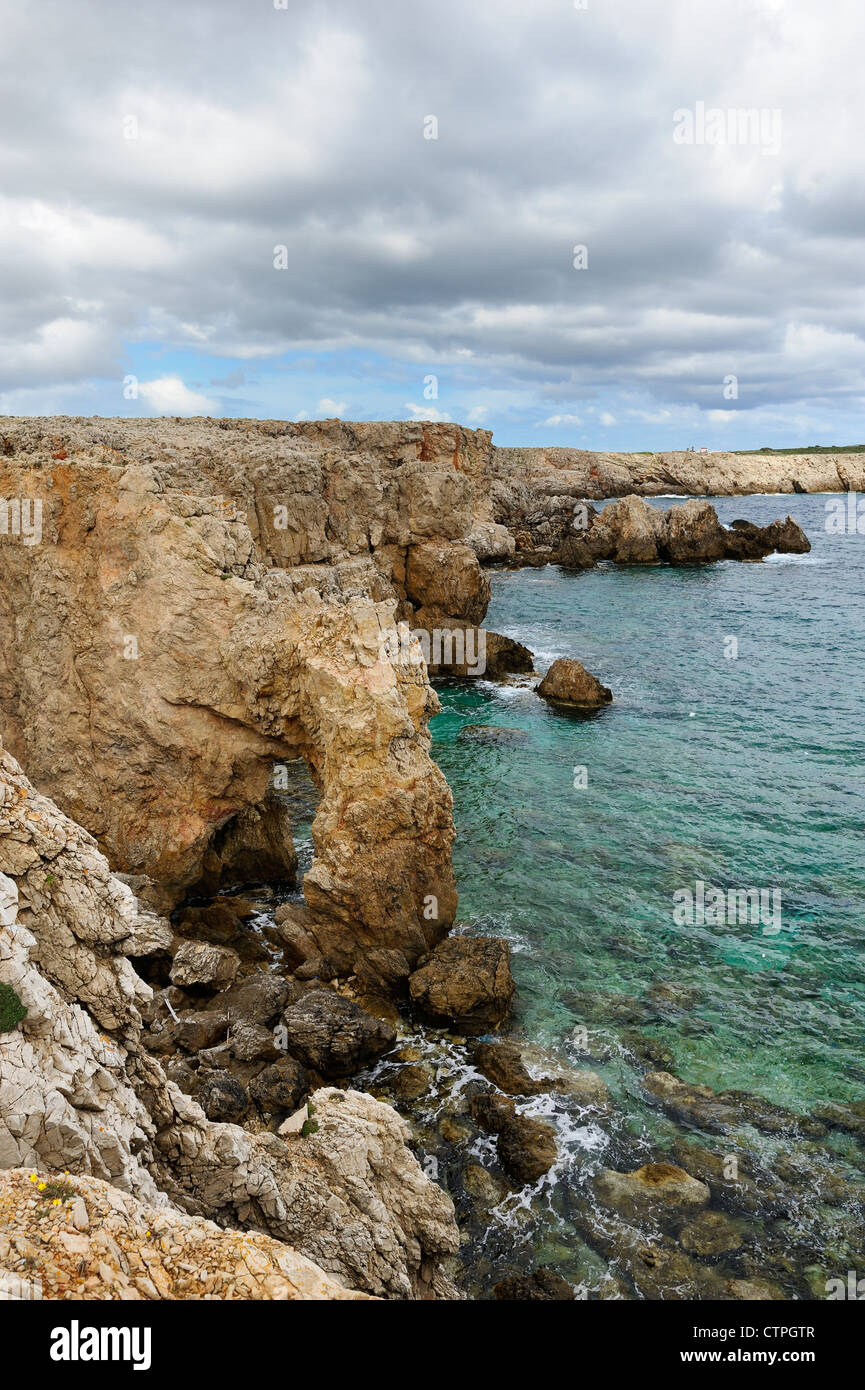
{"left": 0, "top": 423, "right": 464, "bottom": 955}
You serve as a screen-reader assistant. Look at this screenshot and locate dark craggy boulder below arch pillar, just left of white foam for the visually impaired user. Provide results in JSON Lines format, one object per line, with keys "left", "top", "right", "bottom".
{"left": 282, "top": 990, "right": 396, "bottom": 1077}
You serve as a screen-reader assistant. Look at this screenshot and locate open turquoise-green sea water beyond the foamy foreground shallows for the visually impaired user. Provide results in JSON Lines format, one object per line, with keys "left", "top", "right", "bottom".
{"left": 433, "top": 496, "right": 865, "bottom": 1111}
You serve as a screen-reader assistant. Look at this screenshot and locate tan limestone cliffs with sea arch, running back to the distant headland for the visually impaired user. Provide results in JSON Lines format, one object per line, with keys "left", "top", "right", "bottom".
{"left": 0, "top": 417, "right": 865, "bottom": 934}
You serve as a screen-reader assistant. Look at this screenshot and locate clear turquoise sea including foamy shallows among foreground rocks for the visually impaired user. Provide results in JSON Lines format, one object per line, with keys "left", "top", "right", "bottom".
{"left": 265, "top": 496, "right": 865, "bottom": 1298}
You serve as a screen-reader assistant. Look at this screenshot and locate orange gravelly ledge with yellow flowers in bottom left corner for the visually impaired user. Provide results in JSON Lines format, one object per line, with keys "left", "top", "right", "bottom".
{"left": 0, "top": 1168, "right": 369, "bottom": 1302}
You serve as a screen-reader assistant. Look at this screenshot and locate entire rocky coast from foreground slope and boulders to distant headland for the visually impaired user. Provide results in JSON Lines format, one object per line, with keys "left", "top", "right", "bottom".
{"left": 0, "top": 418, "right": 865, "bottom": 1300}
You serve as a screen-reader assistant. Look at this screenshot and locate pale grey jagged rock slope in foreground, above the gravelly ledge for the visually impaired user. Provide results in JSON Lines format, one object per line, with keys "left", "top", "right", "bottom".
{"left": 0, "top": 748, "right": 458, "bottom": 1298}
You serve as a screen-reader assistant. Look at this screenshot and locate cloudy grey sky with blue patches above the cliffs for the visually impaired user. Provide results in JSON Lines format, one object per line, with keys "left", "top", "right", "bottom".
{"left": 0, "top": 0, "right": 865, "bottom": 449}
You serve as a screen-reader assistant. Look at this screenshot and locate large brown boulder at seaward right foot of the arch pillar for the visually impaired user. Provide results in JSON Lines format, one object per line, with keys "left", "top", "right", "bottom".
{"left": 409, "top": 937, "right": 515, "bottom": 1034}
